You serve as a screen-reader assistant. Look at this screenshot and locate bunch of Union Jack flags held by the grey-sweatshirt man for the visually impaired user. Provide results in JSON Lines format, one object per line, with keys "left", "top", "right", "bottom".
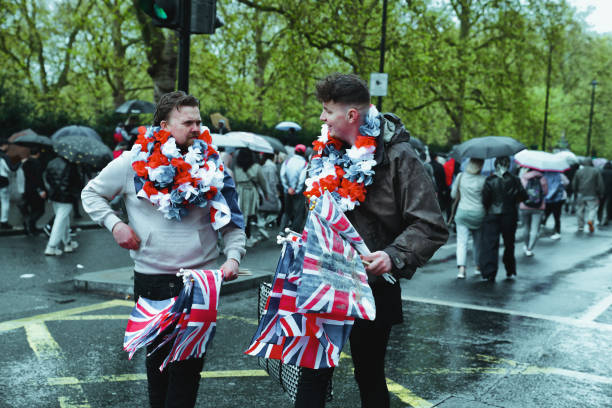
{"left": 123, "top": 270, "right": 223, "bottom": 371}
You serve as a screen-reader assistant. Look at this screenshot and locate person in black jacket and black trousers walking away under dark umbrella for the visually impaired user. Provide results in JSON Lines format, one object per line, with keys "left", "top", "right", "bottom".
{"left": 479, "top": 156, "right": 527, "bottom": 282}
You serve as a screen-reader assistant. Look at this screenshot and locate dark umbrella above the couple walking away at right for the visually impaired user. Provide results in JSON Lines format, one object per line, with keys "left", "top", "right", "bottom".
{"left": 451, "top": 136, "right": 526, "bottom": 160}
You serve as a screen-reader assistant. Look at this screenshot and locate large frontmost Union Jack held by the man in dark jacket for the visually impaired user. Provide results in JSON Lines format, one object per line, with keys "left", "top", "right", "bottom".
{"left": 293, "top": 191, "right": 376, "bottom": 320}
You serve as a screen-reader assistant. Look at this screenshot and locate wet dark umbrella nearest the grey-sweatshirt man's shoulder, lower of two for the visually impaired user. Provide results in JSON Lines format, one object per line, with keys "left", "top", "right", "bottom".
{"left": 53, "top": 136, "right": 113, "bottom": 170}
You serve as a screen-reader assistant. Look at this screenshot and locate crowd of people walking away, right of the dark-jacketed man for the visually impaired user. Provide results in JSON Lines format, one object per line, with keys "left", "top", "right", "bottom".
{"left": 430, "top": 156, "right": 612, "bottom": 281}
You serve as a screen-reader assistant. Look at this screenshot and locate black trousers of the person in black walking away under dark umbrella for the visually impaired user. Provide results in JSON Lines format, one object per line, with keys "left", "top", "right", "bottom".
{"left": 478, "top": 213, "right": 517, "bottom": 280}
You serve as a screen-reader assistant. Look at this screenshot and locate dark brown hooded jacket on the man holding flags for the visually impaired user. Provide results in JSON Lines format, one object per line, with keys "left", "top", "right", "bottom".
{"left": 347, "top": 114, "right": 448, "bottom": 324}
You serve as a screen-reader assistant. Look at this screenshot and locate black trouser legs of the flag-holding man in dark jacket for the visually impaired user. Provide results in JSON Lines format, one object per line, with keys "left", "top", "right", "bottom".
{"left": 295, "top": 319, "right": 391, "bottom": 408}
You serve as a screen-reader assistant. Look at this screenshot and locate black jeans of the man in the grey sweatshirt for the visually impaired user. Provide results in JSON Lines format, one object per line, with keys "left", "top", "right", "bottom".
{"left": 134, "top": 272, "right": 204, "bottom": 408}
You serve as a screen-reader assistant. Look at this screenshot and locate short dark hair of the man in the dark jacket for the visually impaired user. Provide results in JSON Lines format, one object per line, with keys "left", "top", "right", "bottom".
{"left": 317, "top": 73, "right": 370, "bottom": 106}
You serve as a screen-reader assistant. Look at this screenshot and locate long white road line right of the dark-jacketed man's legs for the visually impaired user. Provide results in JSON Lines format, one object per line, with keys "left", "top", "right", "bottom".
{"left": 402, "top": 295, "right": 612, "bottom": 331}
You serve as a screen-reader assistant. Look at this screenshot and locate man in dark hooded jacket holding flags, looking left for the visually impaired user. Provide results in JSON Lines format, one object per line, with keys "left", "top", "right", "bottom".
{"left": 295, "top": 74, "right": 448, "bottom": 408}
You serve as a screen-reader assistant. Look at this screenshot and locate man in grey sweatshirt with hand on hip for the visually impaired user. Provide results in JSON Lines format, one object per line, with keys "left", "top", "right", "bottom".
{"left": 81, "top": 92, "right": 246, "bottom": 408}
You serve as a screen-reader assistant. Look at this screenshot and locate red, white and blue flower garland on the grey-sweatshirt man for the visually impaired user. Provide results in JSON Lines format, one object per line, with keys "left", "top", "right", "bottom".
{"left": 131, "top": 126, "right": 231, "bottom": 229}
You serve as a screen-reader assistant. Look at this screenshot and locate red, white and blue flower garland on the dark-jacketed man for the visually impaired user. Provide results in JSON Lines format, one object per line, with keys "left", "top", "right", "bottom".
{"left": 304, "top": 105, "right": 382, "bottom": 211}
